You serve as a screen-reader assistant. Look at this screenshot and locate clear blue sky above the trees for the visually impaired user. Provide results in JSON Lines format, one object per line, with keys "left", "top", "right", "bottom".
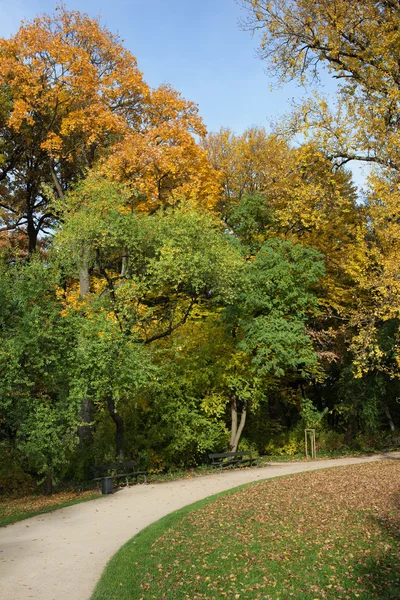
{"left": 0, "top": 0, "right": 364, "bottom": 184}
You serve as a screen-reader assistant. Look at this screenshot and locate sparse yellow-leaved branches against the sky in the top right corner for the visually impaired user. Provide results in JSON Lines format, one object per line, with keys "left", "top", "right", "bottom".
{"left": 244, "top": 0, "right": 400, "bottom": 170}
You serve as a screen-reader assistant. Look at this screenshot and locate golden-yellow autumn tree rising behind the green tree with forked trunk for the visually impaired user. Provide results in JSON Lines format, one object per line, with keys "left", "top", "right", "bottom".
{"left": 204, "top": 128, "right": 372, "bottom": 440}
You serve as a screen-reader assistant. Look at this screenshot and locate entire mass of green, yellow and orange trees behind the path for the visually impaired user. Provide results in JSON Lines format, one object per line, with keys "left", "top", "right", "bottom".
{"left": 0, "top": 0, "right": 400, "bottom": 483}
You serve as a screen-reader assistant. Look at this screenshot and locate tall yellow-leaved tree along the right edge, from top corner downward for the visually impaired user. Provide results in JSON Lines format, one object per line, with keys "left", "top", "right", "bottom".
{"left": 244, "top": 0, "right": 400, "bottom": 432}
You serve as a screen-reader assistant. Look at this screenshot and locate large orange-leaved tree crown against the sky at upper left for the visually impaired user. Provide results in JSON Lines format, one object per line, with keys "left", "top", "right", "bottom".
{"left": 0, "top": 5, "right": 219, "bottom": 251}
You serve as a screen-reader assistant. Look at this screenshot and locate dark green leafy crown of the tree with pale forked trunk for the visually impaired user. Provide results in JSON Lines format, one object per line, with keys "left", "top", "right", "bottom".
{"left": 239, "top": 240, "right": 323, "bottom": 376}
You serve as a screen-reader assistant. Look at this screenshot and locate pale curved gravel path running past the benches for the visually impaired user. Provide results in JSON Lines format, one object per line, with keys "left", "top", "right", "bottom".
{"left": 0, "top": 454, "right": 399, "bottom": 600}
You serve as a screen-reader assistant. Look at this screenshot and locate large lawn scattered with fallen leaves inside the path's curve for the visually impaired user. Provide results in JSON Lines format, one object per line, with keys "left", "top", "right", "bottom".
{"left": 92, "top": 459, "right": 400, "bottom": 600}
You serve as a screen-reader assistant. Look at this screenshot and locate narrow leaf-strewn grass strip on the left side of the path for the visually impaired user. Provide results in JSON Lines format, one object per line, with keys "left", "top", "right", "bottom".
{"left": 0, "top": 490, "right": 100, "bottom": 527}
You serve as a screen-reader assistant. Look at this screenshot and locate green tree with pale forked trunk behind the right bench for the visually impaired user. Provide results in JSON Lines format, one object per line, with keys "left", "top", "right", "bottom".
{"left": 203, "top": 239, "right": 324, "bottom": 451}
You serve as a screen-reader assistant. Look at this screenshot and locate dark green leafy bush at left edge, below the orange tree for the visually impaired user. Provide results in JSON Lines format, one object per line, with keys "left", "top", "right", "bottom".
{"left": 0, "top": 261, "right": 80, "bottom": 488}
